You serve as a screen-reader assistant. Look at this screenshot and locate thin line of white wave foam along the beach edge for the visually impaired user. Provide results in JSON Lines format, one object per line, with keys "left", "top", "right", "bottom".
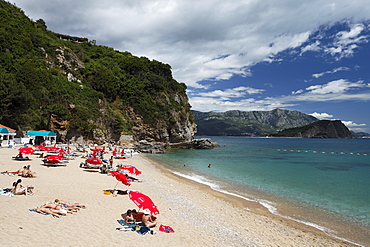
{"left": 171, "top": 171, "right": 365, "bottom": 247}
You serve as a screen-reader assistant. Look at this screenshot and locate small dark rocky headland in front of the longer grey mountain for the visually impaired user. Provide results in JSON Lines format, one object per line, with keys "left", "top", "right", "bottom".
{"left": 274, "top": 120, "right": 353, "bottom": 138}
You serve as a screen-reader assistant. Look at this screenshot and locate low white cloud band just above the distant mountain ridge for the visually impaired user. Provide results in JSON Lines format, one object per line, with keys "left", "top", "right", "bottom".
{"left": 189, "top": 79, "right": 370, "bottom": 112}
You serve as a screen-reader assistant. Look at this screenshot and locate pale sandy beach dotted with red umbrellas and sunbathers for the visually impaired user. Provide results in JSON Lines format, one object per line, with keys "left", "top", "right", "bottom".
{"left": 0, "top": 148, "right": 353, "bottom": 246}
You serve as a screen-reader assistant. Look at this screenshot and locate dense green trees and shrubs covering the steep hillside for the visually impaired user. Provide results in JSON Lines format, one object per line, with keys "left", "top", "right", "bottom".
{"left": 0, "top": 0, "right": 191, "bottom": 140}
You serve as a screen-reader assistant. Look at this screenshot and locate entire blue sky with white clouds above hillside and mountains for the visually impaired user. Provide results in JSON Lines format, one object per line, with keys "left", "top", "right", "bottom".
{"left": 11, "top": 0, "right": 370, "bottom": 133}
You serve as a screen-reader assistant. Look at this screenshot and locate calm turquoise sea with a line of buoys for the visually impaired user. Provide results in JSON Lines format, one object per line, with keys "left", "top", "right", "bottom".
{"left": 146, "top": 136, "right": 370, "bottom": 246}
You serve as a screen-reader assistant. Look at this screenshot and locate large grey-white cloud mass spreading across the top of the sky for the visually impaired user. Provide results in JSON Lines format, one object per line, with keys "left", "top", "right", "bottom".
{"left": 12, "top": 0, "right": 370, "bottom": 88}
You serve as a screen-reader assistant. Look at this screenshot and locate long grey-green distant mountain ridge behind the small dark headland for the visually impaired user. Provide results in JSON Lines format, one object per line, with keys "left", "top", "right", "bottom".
{"left": 192, "top": 109, "right": 318, "bottom": 136}
